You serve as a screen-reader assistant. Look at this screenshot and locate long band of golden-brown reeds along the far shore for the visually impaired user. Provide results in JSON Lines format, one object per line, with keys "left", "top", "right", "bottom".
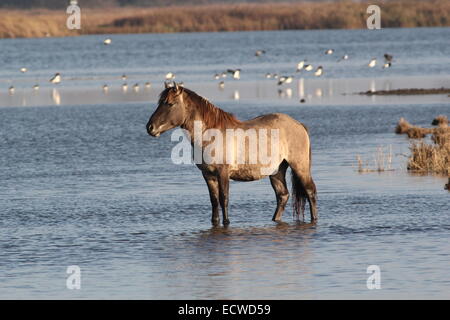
{"left": 0, "top": 0, "right": 450, "bottom": 38}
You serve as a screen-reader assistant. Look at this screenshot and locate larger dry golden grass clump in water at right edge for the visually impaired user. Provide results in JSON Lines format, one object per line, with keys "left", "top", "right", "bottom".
{"left": 396, "top": 116, "right": 450, "bottom": 175}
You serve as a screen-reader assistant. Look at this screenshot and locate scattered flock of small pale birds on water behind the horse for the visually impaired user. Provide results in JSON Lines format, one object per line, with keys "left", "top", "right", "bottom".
{"left": 3, "top": 38, "right": 393, "bottom": 95}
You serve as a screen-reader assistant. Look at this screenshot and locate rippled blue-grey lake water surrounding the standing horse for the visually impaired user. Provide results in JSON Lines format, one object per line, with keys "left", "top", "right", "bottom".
{"left": 0, "top": 29, "right": 450, "bottom": 299}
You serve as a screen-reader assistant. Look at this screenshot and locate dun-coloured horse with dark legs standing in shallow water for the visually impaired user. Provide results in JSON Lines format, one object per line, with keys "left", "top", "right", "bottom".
{"left": 146, "top": 82, "right": 318, "bottom": 226}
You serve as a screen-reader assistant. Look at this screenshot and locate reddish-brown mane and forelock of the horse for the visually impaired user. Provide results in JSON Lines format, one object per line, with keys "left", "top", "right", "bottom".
{"left": 159, "top": 88, "right": 240, "bottom": 129}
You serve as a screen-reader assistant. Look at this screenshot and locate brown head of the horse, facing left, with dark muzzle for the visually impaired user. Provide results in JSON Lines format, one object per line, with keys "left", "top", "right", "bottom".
{"left": 147, "top": 82, "right": 186, "bottom": 137}
